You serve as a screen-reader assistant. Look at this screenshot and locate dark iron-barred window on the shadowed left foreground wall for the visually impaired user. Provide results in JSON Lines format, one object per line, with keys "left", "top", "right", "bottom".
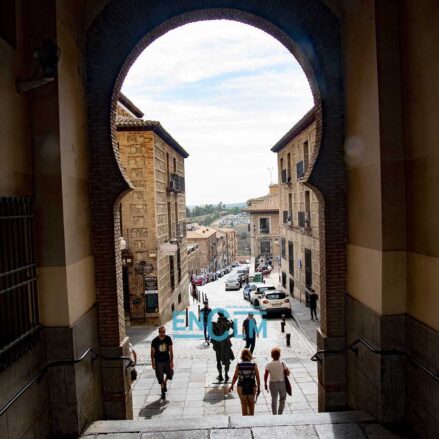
{"left": 0, "top": 197, "right": 40, "bottom": 369}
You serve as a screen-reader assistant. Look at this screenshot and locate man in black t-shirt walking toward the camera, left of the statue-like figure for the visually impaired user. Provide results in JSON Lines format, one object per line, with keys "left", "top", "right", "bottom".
{"left": 151, "top": 326, "right": 174, "bottom": 399}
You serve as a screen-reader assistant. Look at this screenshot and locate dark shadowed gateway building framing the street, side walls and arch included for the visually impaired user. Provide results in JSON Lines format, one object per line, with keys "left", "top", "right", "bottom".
{"left": 0, "top": 0, "right": 439, "bottom": 439}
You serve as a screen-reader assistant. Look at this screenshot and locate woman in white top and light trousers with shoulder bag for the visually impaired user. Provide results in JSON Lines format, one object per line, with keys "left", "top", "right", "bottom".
{"left": 264, "top": 348, "right": 290, "bottom": 415}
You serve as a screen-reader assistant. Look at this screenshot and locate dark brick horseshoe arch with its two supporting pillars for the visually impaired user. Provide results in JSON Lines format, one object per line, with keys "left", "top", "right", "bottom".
{"left": 87, "top": 0, "right": 347, "bottom": 419}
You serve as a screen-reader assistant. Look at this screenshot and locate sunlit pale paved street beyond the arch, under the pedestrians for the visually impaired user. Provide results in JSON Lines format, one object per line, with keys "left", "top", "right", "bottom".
{"left": 127, "top": 266, "right": 317, "bottom": 419}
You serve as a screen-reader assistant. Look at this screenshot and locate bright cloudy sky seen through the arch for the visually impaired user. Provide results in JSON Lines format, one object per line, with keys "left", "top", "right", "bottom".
{"left": 122, "top": 20, "right": 313, "bottom": 205}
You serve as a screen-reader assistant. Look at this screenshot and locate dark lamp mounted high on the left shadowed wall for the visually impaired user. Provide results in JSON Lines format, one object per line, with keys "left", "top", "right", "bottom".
{"left": 16, "top": 38, "right": 61, "bottom": 93}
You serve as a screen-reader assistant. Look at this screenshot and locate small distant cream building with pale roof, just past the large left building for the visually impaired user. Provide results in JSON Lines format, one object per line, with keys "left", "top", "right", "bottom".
{"left": 187, "top": 226, "right": 218, "bottom": 273}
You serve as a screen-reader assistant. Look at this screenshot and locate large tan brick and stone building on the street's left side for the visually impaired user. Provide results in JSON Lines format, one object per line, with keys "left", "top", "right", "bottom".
{"left": 116, "top": 94, "right": 189, "bottom": 324}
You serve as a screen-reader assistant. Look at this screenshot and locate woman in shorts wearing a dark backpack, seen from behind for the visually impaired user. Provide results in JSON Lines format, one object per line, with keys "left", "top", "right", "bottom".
{"left": 229, "top": 349, "right": 261, "bottom": 416}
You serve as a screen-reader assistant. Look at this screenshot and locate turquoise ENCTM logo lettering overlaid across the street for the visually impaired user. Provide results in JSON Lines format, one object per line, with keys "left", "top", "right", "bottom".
{"left": 172, "top": 308, "right": 267, "bottom": 342}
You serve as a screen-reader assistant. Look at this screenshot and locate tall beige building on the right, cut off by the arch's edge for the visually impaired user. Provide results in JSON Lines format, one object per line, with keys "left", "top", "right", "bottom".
{"left": 271, "top": 108, "right": 322, "bottom": 306}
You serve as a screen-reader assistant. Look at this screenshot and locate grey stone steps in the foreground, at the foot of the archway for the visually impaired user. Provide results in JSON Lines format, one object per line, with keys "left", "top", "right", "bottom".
{"left": 81, "top": 411, "right": 410, "bottom": 439}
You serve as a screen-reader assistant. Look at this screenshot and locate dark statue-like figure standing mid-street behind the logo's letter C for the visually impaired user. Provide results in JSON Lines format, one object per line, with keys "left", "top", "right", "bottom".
{"left": 212, "top": 312, "right": 235, "bottom": 382}
